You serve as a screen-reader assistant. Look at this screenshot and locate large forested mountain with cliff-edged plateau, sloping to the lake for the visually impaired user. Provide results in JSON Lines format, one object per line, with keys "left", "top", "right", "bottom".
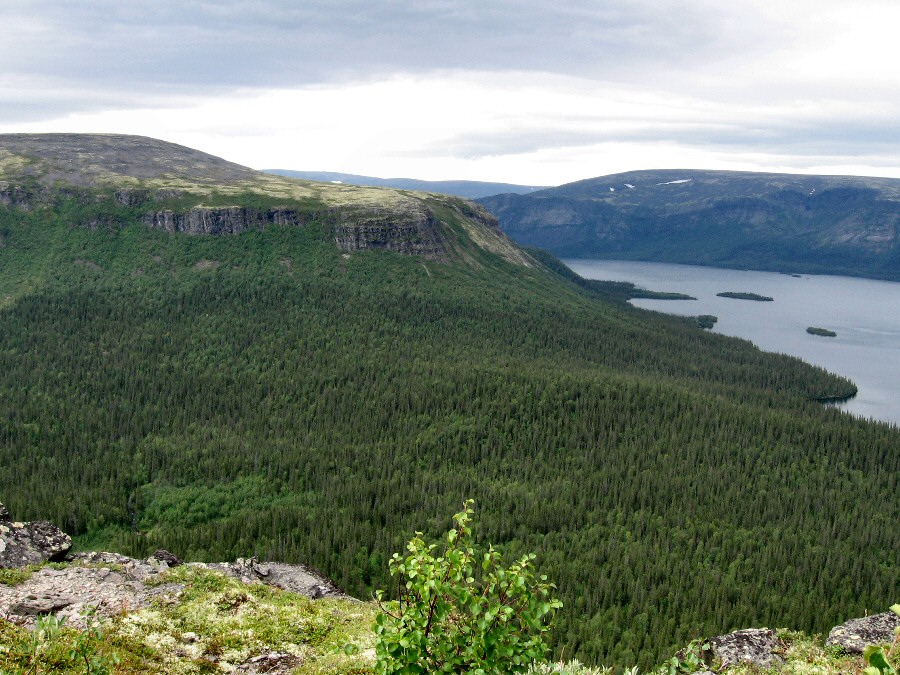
{"left": 0, "top": 135, "right": 900, "bottom": 666}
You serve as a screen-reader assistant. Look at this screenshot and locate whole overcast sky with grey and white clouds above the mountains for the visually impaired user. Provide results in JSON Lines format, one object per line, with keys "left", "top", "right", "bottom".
{"left": 0, "top": 0, "right": 900, "bottom": 185}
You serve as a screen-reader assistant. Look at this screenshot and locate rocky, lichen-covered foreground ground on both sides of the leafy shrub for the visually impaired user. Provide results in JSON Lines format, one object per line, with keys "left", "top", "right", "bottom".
{"left": 0, "top": 504, "right": 900, "bottom": 675}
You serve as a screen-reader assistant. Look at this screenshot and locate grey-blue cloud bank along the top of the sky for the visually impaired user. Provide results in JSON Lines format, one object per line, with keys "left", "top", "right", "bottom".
{"left": 0, "top": 0, "right": 752, "bottom": 105}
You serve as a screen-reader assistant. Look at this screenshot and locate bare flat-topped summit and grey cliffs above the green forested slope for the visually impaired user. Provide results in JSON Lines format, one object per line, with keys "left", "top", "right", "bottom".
{"left": 0, "top": 134, "right": 532, "bottom": 266}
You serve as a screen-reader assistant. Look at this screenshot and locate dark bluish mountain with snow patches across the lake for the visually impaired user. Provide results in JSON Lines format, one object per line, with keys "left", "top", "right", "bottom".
{"left": 478, "top": 170, "right": 900, "bottom": 280}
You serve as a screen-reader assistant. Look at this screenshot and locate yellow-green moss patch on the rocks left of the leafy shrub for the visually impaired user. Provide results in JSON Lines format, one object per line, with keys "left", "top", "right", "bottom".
{"left": 108, "top": 565, "right": 375, "bottom": 673}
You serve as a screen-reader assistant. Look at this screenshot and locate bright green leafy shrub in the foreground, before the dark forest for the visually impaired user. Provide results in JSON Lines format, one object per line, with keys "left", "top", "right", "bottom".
{"left": 375, "top": 500, "right": 562, "bottom": 675}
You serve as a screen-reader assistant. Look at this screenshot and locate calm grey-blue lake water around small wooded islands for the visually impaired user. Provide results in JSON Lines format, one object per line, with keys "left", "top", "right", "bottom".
{"left": 565, "top": 260, "right": 900, "bottom": 425}
